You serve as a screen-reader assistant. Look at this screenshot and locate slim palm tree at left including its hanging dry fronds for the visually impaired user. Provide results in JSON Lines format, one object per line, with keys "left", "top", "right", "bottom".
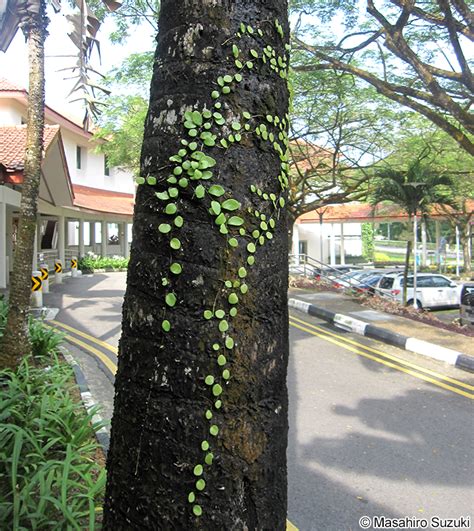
{"left": 0, "top": 0, "right": 120, "bottom": 368}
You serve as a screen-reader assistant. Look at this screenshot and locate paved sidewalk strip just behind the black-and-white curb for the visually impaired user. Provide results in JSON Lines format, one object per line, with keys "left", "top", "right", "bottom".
{"left": 289, "top": 288, "right": 474, "bottom": 356}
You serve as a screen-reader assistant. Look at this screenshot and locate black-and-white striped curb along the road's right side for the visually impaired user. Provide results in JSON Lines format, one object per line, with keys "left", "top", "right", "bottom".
{"left": 288, "top": 298, "right": 474, "bottom": 372}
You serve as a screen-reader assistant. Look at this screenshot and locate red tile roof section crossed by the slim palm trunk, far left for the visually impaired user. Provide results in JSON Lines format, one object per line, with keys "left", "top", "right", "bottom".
{"left": 0, "top": 125, "right": 59, "bottom": 171}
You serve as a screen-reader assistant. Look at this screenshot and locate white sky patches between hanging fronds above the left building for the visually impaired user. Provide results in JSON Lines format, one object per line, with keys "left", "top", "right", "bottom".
{"left": 0, "top": 4, "right": 155, "bottom": 123}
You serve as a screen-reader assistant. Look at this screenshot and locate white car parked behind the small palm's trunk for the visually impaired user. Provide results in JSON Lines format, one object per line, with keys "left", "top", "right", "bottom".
{"left": 377, "top": 273, "right": 462, "bottom": 308}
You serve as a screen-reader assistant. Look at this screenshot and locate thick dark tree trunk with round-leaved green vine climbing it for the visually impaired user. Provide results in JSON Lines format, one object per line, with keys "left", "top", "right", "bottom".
{"left": 104, "top": 0, "right": 288, "bottom": 531}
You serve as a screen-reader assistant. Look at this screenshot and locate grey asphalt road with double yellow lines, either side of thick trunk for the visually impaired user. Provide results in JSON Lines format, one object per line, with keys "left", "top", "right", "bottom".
{"left": 45, "top": 273, "right": 474, "bottom": 531}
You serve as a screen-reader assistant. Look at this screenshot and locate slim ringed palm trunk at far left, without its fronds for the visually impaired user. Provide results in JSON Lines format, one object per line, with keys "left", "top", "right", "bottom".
{"left": 0, "top": 0, "right": 48, "bottom": 368}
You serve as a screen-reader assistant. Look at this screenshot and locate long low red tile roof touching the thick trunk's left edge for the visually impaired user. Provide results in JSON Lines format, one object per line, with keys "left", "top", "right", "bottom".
{"left": 73, "top": 184, "right": 135, "bottom": 216}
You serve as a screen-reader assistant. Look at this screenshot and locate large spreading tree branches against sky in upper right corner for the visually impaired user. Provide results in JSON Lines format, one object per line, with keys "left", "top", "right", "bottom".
{"left": 293, "top": 0, "right": 474, "bottom": 155}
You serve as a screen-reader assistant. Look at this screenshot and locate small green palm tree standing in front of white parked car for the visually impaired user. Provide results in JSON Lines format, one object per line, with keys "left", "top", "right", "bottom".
{"left": 371, "top": 160, "right": 452, "bottom": 305}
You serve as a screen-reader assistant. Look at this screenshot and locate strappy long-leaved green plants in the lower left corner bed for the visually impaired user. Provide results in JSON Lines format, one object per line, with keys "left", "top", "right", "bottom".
{"left": 0, "top": 301, "right": 105, "bottom": 531}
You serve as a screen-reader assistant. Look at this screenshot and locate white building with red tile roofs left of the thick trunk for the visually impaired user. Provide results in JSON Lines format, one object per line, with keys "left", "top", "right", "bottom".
{"left": 0, "top": 78, "right": 135, "bottom": 288}
